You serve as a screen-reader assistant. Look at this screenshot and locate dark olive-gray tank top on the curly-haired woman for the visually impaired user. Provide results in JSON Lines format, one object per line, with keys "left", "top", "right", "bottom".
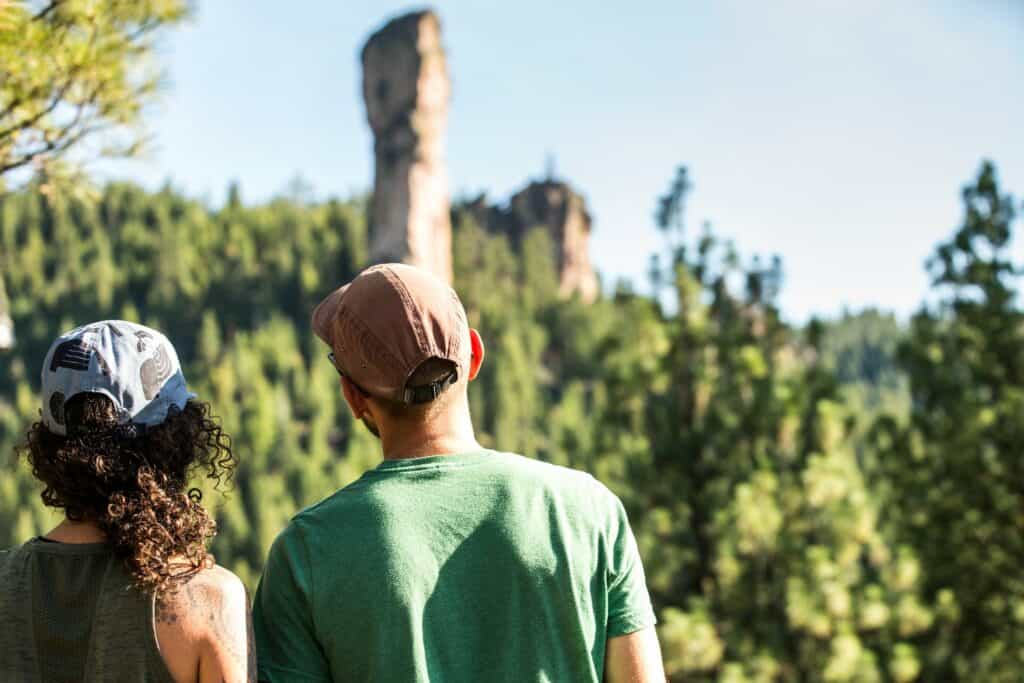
{"left": 0, "top": 539, "right": 174, "bottom": 683}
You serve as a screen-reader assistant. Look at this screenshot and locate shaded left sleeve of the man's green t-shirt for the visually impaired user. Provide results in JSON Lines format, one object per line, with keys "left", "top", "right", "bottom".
{"left": 253, "top": 524, "right": 331, "bottom": 683}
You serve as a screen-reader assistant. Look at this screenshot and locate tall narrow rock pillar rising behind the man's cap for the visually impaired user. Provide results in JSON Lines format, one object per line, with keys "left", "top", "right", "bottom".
{"left": 362, "top": 11, "right": 452, "bottom": 283}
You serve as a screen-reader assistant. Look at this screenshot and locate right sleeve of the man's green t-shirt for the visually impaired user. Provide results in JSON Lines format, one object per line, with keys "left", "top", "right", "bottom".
{"left": 607, "top": 497, "right": 657, "bottom": 638}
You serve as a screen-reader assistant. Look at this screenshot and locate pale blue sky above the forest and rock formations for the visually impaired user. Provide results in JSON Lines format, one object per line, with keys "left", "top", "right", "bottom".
{"left": 99, "top": 0, "right": 1024, "bottom": 321}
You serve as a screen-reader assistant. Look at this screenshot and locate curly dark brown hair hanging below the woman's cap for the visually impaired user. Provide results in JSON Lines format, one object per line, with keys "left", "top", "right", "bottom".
{"left": 18, "top": 393, "right": 237, "bottom": 592}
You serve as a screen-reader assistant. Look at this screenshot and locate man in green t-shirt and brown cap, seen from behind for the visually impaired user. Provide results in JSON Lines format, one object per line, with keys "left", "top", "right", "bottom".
{"left": 254, "top": 264, "right": 665, "bottom": 683}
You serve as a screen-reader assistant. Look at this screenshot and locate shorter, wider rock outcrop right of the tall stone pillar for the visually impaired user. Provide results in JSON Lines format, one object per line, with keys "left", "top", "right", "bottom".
{"left": 462, "top": 178, "right": 600, "bottom": 303}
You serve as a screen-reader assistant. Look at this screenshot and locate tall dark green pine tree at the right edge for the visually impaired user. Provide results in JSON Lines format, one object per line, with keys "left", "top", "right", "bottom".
{"left": 876, "top": 162, "right": 1024, "bottom": 682}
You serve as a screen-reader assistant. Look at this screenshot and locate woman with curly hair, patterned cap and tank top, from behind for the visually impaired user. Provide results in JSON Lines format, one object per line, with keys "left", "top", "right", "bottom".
{"left": 0, "top": 321, "right": 255, "bottom": 683}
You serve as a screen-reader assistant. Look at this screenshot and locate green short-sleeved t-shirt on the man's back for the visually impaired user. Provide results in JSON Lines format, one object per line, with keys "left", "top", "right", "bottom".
{"left": 254, "top": 451, "right": 654, "bottom": 683}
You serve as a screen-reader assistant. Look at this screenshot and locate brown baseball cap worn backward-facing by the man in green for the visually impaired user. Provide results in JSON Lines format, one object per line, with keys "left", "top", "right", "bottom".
{"left": 312, "top": 263, "right": 472, "bottom": 404}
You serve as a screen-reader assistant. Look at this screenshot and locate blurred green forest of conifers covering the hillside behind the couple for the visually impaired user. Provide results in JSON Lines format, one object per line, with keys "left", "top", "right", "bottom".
{"left": 0, "top": 164, "right": 1024, "bottom": 683}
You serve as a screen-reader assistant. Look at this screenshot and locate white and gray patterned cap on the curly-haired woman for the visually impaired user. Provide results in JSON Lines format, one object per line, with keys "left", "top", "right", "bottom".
{"left": 42, "top": 321, "right": 196, "bottom": 435}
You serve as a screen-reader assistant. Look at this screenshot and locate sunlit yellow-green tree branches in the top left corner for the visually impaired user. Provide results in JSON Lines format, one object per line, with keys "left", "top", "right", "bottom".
{"left": 0, "top": 0, "right": 188, "bottom": 184}
